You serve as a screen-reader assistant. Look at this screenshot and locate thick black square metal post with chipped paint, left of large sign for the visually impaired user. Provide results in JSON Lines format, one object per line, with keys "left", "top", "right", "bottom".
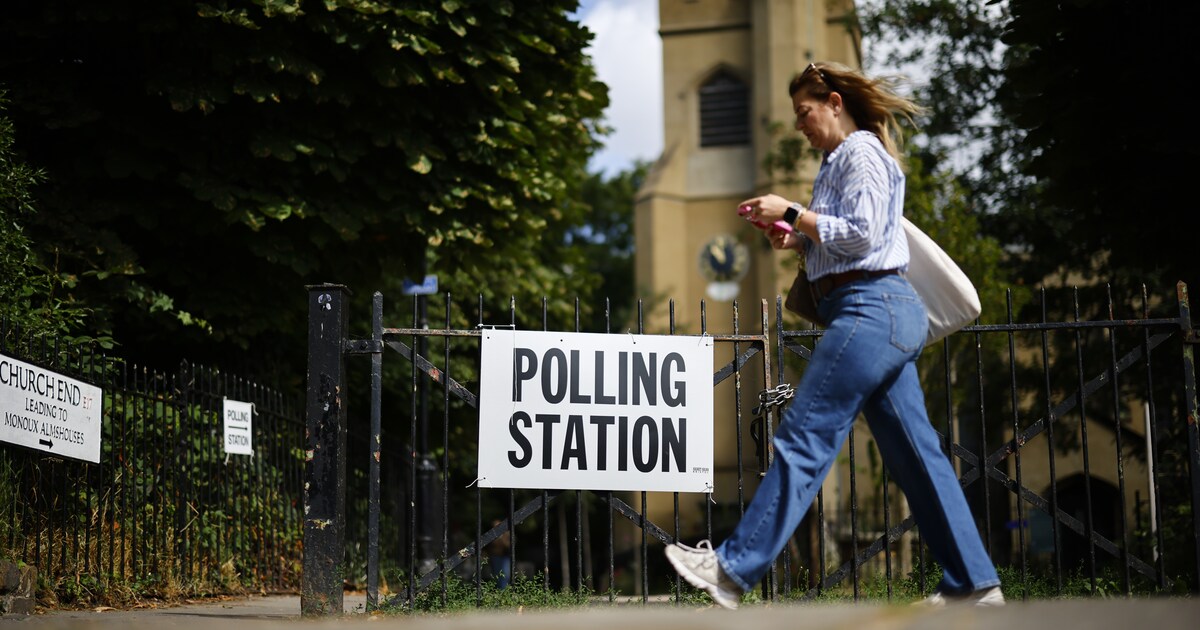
{"left": 300, "top": 284, "right": 350, "bottom": 617}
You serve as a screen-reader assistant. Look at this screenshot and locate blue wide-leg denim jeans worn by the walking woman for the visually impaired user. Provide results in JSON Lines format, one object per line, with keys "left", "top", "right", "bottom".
{"left": 716, "top": 276, "right": 1000, "bottom": 594}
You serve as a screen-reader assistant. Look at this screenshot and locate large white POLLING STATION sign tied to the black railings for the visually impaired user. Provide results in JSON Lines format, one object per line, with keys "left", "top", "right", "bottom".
{"left": 479, "top": 330, "right": 713, "bottom": 492}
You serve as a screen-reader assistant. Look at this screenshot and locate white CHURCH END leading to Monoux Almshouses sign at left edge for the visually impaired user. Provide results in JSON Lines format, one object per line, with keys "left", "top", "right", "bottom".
{"left": 0, "top": 354, "right": 104, "bottom": 463}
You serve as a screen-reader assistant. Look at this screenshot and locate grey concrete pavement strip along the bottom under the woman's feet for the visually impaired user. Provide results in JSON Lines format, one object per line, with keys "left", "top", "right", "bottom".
{"left": 0, "top": 595, "right": 1200, "bottom": 630}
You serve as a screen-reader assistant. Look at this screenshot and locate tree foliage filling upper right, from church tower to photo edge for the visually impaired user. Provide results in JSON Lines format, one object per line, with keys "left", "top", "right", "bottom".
{"left": 859, "top": 0, "right": 1200, "bottom": 308}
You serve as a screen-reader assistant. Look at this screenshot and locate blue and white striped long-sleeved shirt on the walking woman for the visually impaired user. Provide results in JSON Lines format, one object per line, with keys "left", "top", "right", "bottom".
{"left": 805, "top": 131, "right": 908, "bottom": 280}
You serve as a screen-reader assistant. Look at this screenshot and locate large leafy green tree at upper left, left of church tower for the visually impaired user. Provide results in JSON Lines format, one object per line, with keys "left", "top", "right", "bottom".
{"left": 0, "top": 0, "right": 607, "bottom": 373}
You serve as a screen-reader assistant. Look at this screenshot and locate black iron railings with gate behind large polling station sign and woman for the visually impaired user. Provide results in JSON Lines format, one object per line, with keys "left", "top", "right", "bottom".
{"left": 302, "top": 284, "right": 1200, "bottom": 614}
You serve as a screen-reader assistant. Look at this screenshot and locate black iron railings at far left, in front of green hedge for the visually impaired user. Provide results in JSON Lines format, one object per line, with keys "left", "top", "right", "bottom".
{"left": 0, "top": 326, "right": 304, "bottom": 601}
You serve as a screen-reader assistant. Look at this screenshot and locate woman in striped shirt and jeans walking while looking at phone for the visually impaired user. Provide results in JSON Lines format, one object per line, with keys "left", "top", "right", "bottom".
{"left": 666, "top": 62, "right": 1004, "bottom": 608}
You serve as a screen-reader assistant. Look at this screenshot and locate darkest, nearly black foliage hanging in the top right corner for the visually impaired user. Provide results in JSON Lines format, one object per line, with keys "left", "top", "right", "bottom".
{"left": 992, "top": 0, "right": 1200, "bottom": 295}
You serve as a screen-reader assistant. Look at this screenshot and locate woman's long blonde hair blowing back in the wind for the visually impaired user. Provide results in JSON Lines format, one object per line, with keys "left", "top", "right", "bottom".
{"left": 787, "top": 61, "right": 924, "bottom": 163}
